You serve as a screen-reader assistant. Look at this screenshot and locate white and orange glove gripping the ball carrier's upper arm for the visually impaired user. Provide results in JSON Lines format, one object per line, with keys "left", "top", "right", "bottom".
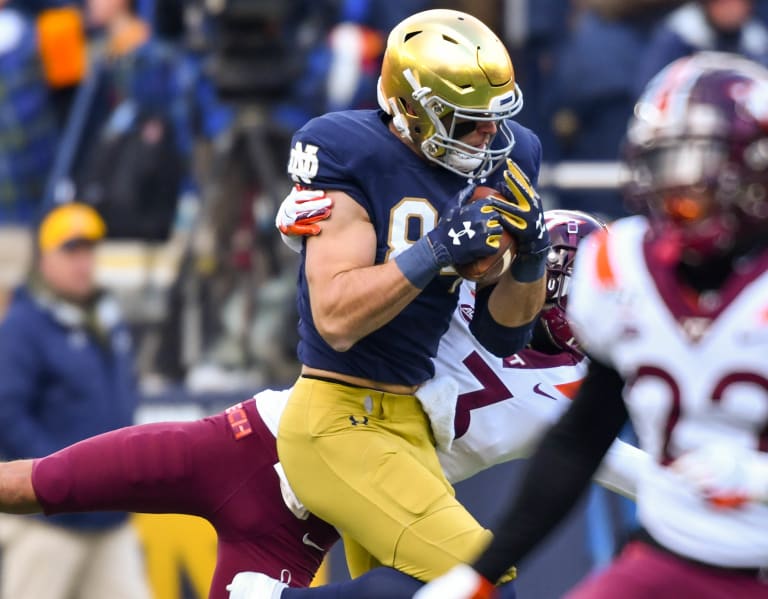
{"left": 275, "top": 185, "right": 333, "bottom": 252}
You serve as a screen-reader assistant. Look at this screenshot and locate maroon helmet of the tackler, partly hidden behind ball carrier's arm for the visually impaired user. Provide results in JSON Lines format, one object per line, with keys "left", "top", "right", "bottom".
{"left": 539, "top": 210, "right": 606, "bottom": 355}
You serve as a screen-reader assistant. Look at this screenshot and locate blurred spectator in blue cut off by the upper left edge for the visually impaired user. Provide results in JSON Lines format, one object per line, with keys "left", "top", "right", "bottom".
{"left": 0, "top": 0, "right": 58, "bottom": 225}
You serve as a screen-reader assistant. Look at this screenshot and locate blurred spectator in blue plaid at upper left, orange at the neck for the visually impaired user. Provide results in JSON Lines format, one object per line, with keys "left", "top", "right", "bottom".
{"left": 73, "top": 0, "right": 232, "bottom": 241}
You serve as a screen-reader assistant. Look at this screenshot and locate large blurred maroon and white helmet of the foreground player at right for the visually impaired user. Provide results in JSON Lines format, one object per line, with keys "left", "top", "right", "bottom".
{"left": 624, "top": 52, "right": 768, "bottom": 260}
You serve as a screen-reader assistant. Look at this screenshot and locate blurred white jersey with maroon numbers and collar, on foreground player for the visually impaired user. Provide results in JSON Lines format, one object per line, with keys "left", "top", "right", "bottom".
{"left": 568, "top": 217, "right": 768, "bottom": 567}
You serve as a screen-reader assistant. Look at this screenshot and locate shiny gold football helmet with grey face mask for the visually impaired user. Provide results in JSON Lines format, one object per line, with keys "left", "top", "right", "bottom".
{"left": 378, "top": 9, "right": 523, "bottom": 179}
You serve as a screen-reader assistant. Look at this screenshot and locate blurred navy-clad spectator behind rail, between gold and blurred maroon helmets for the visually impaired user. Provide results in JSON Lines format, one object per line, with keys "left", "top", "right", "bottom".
{"left": 538, "top": 0, "right": 679, "bottom": 219}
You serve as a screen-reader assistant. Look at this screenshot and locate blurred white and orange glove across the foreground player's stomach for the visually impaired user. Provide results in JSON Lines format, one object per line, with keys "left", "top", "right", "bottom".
{"left": 670, "top": 444, "right": 768, "bottom": 508}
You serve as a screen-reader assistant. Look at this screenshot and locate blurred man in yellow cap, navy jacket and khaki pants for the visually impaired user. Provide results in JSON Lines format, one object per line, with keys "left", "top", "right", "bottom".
{"left": 0, "top": 202, "right": 150, "bottom": 599}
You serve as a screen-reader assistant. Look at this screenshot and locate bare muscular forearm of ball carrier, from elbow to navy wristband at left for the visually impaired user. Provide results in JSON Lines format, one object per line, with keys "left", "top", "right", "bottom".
{"left": 310, "top": 262, "right": 421, "bottom": 351}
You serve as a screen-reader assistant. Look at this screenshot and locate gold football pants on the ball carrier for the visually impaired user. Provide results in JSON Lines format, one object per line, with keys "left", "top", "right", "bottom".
{"left": 277, "top": 377, "right": 491, "bottom": 581}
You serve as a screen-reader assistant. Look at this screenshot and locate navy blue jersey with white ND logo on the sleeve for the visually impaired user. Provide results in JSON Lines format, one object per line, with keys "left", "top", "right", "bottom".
{"left": 288, "top": 110, "right": 541, "bottom": 385}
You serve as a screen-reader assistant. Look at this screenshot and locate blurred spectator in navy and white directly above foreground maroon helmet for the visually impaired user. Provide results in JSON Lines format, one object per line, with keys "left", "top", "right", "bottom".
{"left": 634, "top": 0, "right": 768, "bottom": 96}
